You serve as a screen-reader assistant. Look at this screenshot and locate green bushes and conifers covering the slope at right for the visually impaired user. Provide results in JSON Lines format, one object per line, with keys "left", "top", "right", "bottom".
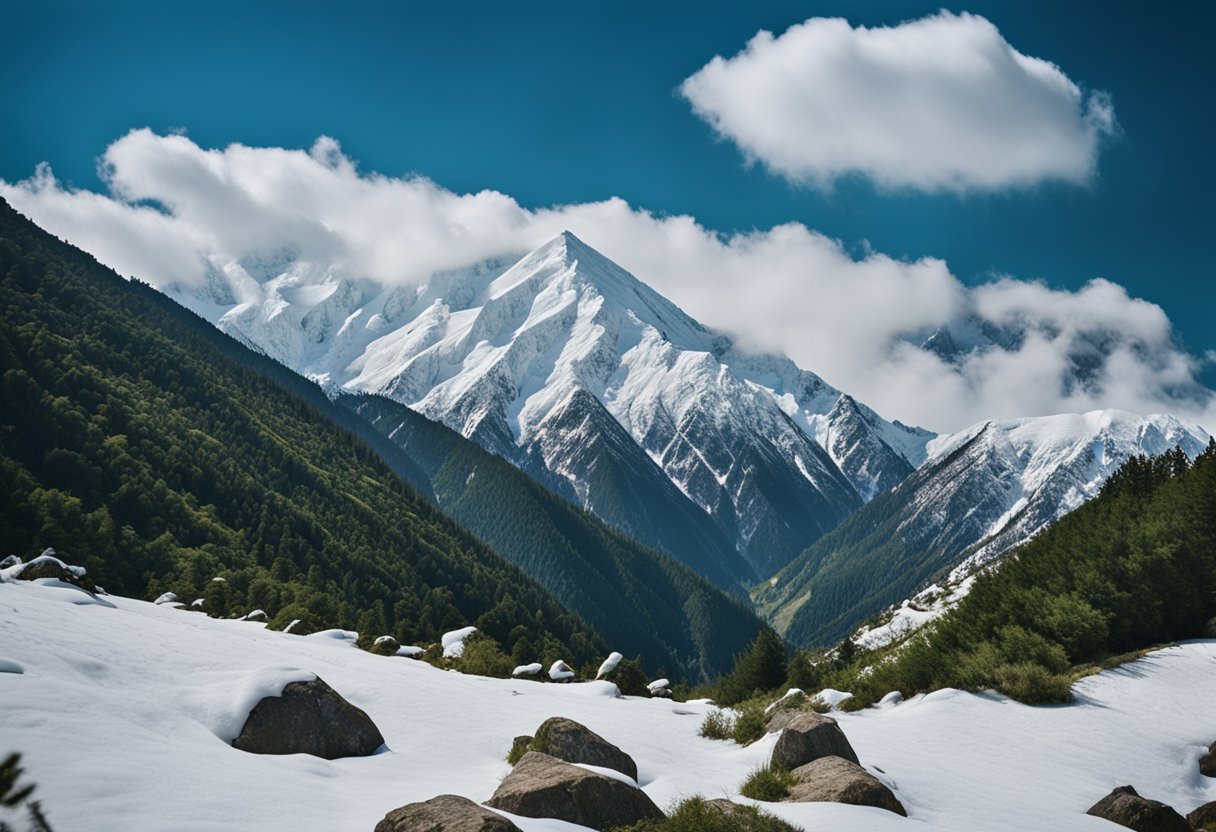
{"left": 831, "top": 440, "right": 1216, "bottom": 703}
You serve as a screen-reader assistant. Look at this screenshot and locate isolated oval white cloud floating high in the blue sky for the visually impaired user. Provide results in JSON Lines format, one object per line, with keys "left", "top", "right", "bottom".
{"left": 680, "top": 11, "right": 1116, "bottom": 191}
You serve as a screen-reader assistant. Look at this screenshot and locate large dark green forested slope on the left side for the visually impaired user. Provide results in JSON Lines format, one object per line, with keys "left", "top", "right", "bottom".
{"left": 0, "top": 193, "right": 606, "bottom": 662}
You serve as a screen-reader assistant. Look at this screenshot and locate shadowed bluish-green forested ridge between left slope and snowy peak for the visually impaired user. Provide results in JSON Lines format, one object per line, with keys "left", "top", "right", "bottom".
{"left": 340, "top": 397, "right": 762, "bottom": 693}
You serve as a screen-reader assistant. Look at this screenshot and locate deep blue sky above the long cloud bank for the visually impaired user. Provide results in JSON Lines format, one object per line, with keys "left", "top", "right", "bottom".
{"left": 0, "top": 0, "right": 1216, "bottom": 367}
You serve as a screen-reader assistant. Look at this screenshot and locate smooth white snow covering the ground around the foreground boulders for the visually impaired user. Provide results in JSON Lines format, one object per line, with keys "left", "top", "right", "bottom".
{"left": 0, "top": 583, "right": 1216, "bottom": 832}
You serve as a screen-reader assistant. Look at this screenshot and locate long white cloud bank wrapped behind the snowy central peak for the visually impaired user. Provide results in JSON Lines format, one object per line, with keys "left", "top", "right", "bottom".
{"left": 0, "top": 130, "right": 1216, "bottom": 431}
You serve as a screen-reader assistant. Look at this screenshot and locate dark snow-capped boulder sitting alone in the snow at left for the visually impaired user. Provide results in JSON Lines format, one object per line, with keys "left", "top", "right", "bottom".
{"left": 232, "top": 679, "right": 384, "bottom": 760}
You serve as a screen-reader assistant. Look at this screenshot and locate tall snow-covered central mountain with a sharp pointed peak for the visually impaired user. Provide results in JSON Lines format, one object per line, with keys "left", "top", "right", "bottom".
{"left": 175, "top": 227, "right": 933, "bottom": 586}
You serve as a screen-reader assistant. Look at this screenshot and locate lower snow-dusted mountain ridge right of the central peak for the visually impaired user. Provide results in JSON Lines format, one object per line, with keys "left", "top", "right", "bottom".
{"left": 753, "top": 410, "right": 1209, "bottom": 645}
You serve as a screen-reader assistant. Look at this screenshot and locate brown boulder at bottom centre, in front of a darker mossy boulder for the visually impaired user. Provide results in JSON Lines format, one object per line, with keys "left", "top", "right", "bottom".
{"left": 486, "top": 752, "right": 664, "bottom": 830}
